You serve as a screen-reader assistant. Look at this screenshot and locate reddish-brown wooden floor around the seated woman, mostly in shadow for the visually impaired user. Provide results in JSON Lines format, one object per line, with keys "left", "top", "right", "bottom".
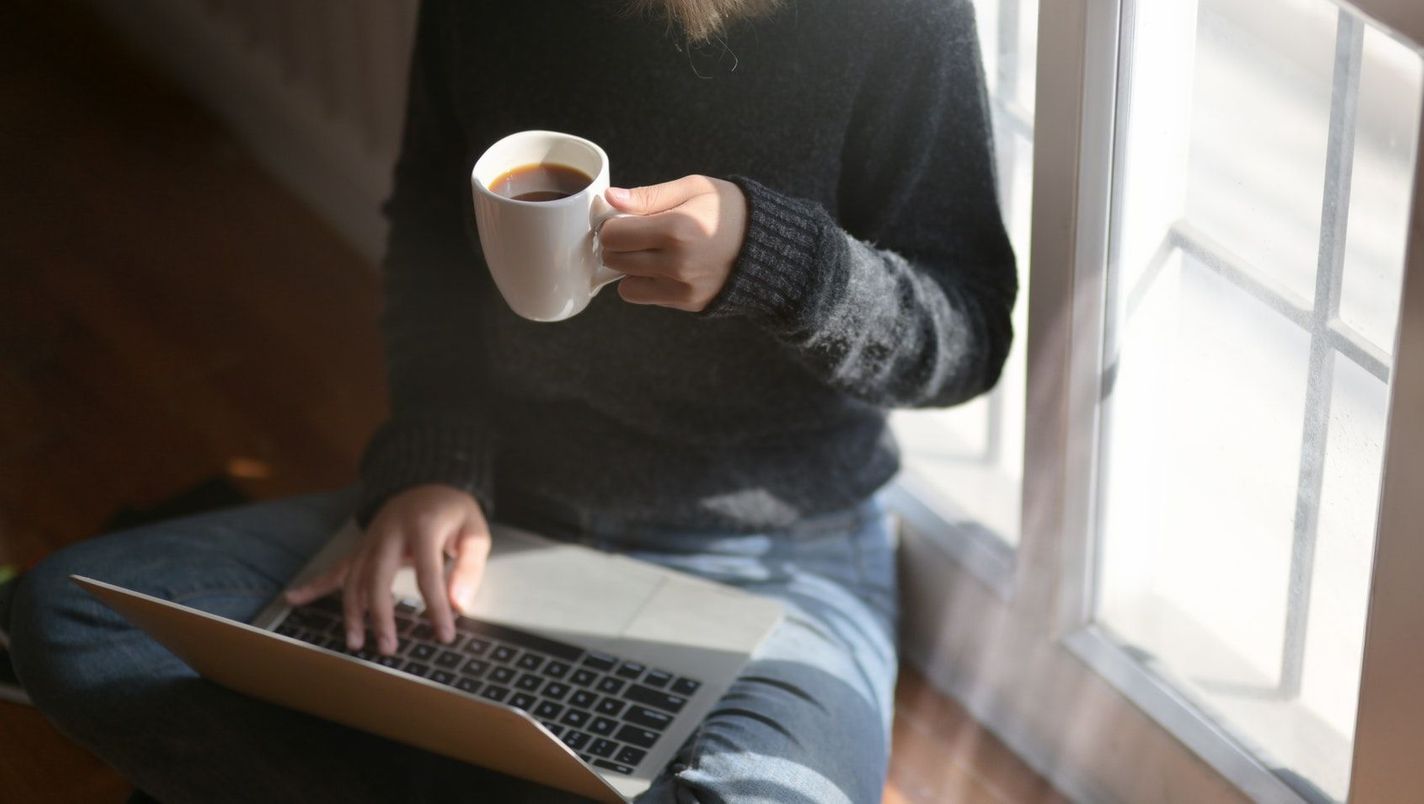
{"left": 0, "top": 0, "right": 1061, "bottom": 804}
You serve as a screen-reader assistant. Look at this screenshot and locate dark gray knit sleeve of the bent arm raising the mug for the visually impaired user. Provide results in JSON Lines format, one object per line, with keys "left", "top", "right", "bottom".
{"left": 703, "top": 0, "right": 1017, "bottom": 407}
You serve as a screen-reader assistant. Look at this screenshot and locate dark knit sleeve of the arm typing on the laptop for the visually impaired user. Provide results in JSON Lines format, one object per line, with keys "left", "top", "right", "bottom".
{"left": 357, "top": 0, "right": 493, "bottom": 522}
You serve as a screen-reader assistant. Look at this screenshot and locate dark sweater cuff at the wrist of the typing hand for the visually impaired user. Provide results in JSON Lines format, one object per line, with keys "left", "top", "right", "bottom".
{"left": 356, "top": 417, "right": 493, "bottom": 528}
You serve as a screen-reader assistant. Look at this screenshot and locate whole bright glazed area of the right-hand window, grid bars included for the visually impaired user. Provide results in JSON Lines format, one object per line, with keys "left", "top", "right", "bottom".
{"left": 1095, "top": 0, "right": 1424, "bottom": 800}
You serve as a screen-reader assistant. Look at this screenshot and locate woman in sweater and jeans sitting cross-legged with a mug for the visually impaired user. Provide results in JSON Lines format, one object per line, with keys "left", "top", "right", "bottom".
{"left": 8, "top": 0, "right": 1015, "bottom": 803}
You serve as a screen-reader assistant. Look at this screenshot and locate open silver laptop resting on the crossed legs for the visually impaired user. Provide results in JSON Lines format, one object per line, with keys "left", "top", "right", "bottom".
{"left": 73, "top": 522, "right": 782, "bottom": 801}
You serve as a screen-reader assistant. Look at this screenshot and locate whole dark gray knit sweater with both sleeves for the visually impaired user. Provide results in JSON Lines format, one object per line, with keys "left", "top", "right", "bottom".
{"left": 362, "top": 0, "right": 1017, "bottom": 531}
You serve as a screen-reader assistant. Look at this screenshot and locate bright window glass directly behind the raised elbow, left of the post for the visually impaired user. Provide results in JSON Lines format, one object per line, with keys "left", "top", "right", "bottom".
{"left": 891, "top": 0, "right": 1038, "bottom": 545}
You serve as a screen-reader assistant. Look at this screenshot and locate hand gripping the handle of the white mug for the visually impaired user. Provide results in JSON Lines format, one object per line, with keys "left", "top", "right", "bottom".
{"left": 600, "top": 176, "right": 746, "bottom": 312}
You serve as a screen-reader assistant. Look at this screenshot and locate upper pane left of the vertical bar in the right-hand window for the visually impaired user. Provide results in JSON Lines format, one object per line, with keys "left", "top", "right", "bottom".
{"left": 1179, "top": 0, "right": 1334, "bottom": 302}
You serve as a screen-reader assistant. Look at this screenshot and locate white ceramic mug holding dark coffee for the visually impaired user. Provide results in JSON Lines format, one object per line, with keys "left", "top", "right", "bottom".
{"left": 470, "top": 131, "right": 624, "bottom": 322}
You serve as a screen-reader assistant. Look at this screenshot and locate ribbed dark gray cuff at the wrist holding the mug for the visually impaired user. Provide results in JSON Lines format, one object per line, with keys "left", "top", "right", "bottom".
{"left": 702, "top": 176, "right": 836, "bottom": 329}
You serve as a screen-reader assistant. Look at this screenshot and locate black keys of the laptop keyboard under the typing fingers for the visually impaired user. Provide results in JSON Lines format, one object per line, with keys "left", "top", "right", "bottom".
{"left": 273, "top": 596, "right": 702, "bottom": 774}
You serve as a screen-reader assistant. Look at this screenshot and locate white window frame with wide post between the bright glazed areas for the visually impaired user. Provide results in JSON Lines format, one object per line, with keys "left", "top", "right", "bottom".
{"left": 893, "top": 0, "right": 1424, "bottom": 803}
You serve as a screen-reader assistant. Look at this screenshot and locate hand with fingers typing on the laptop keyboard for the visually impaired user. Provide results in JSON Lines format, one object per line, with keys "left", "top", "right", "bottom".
{"left": 286, "top": 485, "right": 490, "bottom": 655}
